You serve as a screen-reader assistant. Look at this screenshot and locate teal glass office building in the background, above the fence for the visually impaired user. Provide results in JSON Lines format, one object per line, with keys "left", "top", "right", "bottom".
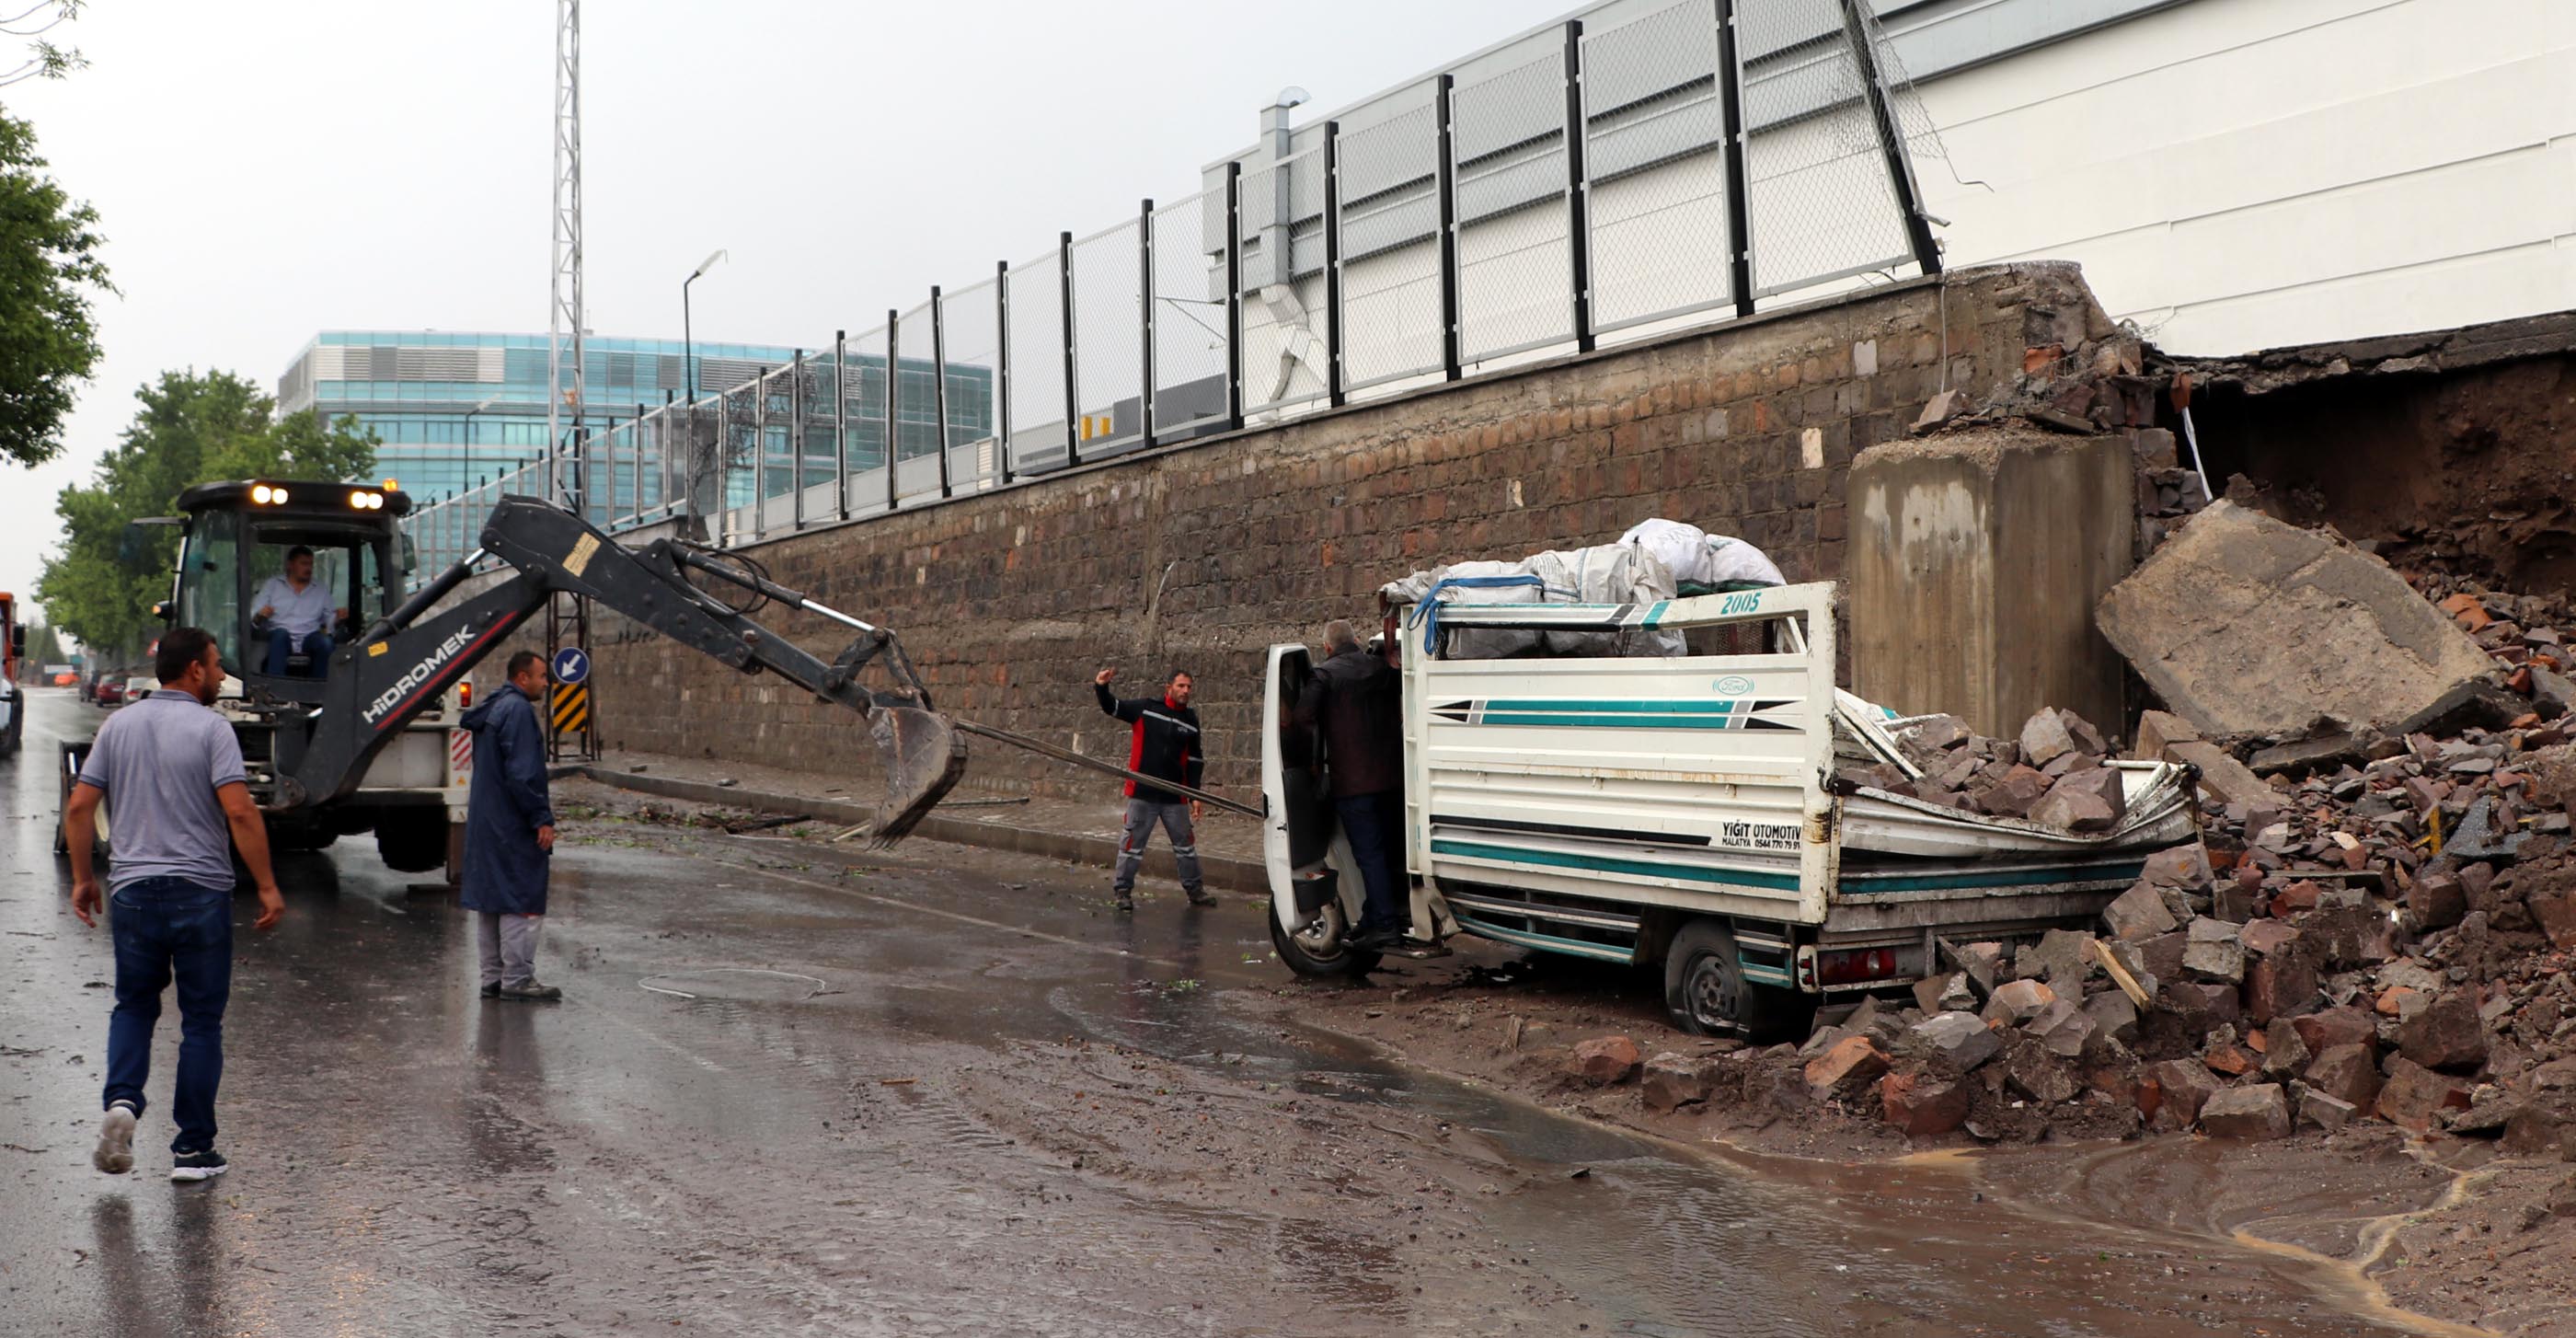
{"left": 278, "top": 330, "right": 809, "bottom": 502}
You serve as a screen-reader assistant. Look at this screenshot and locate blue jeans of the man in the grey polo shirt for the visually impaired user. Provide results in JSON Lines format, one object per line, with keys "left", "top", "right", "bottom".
{"left": 98, "top": 879, "right": 232, "bottom": 1152}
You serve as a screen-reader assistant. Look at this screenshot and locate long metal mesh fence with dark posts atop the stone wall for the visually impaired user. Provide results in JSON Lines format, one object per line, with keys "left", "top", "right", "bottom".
{"left": 391, "top": 0, "right": 1942, "bottom": 554}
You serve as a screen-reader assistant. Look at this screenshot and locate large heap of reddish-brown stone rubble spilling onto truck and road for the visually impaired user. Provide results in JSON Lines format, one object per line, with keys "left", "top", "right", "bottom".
{"left": 1577, "top": 520, "right": 2576, "bottom": 1160}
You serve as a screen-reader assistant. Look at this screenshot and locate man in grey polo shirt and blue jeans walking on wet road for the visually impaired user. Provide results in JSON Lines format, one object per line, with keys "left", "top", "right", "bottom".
{"left": 62, "top": 627, "right": 286, "bottom": 1181}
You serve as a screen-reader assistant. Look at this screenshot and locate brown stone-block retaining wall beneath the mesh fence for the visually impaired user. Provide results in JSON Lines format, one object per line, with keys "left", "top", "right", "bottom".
{"left": 564, "top": 266, "right": 2092, "bottom": 797}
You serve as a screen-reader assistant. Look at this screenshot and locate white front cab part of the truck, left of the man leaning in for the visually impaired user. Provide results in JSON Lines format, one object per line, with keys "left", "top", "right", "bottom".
{"left": 1262, "top": 644, "right": 1378, "bottom": 975}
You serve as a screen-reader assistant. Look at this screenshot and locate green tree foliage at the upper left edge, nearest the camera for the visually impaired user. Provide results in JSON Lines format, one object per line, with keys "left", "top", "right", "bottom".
{"left": 0, "top": 103, "right": 116, "bottom": 464}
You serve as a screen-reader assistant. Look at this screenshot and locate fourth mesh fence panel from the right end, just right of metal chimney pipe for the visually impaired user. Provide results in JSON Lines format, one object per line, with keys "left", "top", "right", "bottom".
{"left": 1334, "top": 87, "right": 1440, "bottom": 392}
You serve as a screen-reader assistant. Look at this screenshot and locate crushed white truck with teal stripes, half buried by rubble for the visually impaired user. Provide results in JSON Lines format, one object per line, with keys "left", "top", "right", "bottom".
{"left": 1262, "top": 571, "right": 2197, "bottom": 1036}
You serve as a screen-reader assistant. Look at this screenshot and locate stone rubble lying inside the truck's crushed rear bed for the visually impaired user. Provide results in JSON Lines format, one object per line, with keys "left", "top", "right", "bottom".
{"left": 1836, "top": 711, "right": 2125, "bottom": 833}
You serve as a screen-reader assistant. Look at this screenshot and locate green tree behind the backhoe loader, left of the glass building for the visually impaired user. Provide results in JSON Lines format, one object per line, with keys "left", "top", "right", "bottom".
{"left": 36, "top": 371, "right": 376, "bottom": 655}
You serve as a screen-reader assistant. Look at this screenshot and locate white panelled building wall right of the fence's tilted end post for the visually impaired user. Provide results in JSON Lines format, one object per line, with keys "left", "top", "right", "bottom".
{"left": 1926, "top": 0, "right": 2576, "bottom": 353}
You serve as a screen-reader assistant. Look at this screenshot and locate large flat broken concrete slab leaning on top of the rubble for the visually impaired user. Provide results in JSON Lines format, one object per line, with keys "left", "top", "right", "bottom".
{"left": 2097, "top": 500, "right": 2491, "bottom": 734}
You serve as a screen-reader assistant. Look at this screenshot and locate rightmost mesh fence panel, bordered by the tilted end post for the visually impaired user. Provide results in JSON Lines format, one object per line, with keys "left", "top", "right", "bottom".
{"left": 1736, "top": 0, "right": 1909, "bottom": 294}
